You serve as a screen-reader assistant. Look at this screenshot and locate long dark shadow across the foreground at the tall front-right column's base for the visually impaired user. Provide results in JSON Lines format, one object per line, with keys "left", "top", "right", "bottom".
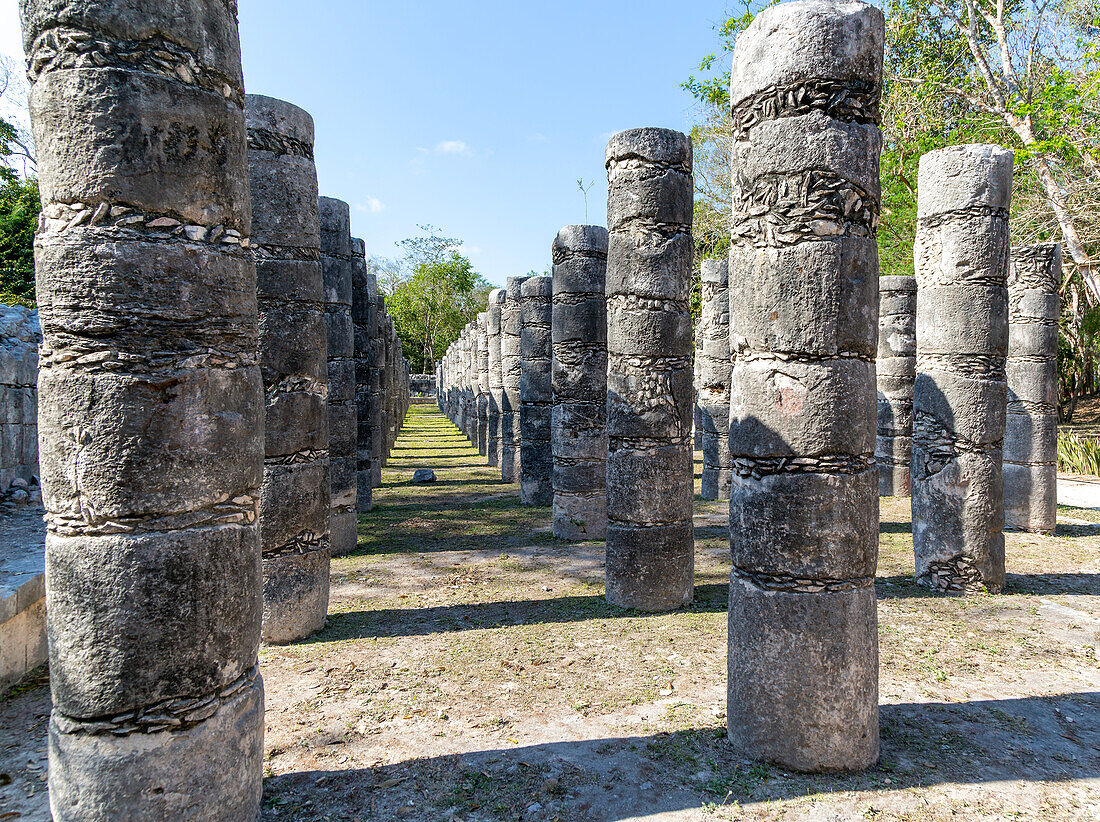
{"left": 263, "top": 692, "right": 1100, "bottom": 822}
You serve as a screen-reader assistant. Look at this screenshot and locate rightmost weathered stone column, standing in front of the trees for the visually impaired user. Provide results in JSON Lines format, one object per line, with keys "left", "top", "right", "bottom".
{"left": 1003, "top": 243, "right": 1062, "bottom": 534}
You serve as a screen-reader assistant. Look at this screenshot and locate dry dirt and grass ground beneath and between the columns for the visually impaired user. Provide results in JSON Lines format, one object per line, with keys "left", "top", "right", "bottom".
{"left": 0, "top": 396, "right": 1100, "bottom": 822}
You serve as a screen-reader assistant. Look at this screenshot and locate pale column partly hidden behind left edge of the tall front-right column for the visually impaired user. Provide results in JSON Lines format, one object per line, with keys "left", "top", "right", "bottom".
{"left": 695, "top": 260, "right": 733, "bottom": 500}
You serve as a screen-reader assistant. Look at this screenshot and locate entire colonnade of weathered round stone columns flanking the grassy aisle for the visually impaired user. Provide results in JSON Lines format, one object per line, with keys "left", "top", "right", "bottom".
{"left": 27, "top": 0, "right": 1060, "bottom": 822}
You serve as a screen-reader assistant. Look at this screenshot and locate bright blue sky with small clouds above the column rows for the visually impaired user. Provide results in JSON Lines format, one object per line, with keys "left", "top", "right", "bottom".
{"left": 0, "top": 0, "right": 727, "bottom": 285}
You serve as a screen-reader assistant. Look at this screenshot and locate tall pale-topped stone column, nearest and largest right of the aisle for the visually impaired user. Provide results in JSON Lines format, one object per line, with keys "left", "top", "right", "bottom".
{"left": 727, "top": 0, "right": 886, "bottom": 771}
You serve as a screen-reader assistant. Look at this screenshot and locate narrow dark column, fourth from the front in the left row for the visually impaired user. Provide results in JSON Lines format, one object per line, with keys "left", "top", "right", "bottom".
{"left": 351, "top": 237, "right": 377, "bottom": 514}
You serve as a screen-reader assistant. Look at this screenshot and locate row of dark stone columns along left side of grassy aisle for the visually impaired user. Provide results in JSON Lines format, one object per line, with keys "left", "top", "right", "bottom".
{"left": 20, "top": 0, "right": 409, "bottom": 821}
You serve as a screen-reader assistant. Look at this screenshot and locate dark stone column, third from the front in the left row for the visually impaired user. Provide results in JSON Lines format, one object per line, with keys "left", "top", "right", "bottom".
{"left": 319, "top": 197, "right": 358, "bottom": 557}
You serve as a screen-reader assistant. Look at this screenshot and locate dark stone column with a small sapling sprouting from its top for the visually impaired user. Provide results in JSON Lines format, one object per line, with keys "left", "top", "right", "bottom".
{"left": 550, "top": 226, "right": 607, "bottom": 539}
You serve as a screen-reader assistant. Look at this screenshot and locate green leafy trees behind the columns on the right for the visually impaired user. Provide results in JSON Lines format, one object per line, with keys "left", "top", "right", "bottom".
{"left": 682, "top": 0, "right": 1100, "bottom": 411}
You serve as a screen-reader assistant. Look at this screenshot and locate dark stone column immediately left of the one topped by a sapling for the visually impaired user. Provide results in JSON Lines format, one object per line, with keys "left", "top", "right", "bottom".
{"left": 519, "top": 276, "right": 553, "bottom": 506}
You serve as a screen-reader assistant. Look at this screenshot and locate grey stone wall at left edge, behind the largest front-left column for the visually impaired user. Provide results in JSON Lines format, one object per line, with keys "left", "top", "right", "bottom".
{"left": 0, "top": 306, "right": 42, "bottom": 498}
